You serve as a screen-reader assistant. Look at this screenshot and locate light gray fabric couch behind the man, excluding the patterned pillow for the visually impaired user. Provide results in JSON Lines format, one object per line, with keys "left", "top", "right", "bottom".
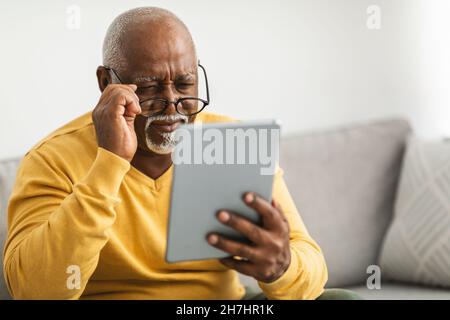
{"left": 0, "top": 119, "right": 450, "bottom": 299}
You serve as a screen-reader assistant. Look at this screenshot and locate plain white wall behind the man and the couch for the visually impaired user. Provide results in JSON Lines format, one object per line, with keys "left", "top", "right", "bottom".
{"left": 0, "top": 0, "right": 450, "bottom": 158}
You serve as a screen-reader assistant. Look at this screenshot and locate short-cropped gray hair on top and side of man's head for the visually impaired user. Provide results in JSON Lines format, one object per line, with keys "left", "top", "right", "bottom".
{"left": 103, "top": 7, "right": 195, "bottom": 70}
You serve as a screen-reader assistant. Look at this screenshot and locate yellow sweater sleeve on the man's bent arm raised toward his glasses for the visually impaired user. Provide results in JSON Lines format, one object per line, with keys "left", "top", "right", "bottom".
{"left": 3, "top": 148, "right": 130, "bottom": 299}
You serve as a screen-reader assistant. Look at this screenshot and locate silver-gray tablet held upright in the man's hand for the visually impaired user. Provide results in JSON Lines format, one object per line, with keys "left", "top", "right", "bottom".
{"left": 166, "top": 120, "right": 280, "bottom": 262}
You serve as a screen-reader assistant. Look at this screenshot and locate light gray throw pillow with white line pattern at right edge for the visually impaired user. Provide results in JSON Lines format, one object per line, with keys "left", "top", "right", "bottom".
{"left": 380, "top": 138, "right": 450, "bottom": 288}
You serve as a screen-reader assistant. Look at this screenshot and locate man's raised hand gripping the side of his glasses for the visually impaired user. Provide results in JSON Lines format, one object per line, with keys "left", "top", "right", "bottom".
{"left": 92, "top": 84, "right": 141, "bottom": 161}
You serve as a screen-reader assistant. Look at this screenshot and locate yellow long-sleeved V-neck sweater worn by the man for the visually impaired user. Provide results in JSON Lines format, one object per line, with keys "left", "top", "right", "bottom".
{"left": 3, "top": 112, "right": 327, "bottom": 299}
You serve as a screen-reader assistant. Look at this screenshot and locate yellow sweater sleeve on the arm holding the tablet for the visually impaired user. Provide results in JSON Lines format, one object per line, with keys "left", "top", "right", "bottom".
{"left": 258, "top": 169, "right": 328, "bottom": 300}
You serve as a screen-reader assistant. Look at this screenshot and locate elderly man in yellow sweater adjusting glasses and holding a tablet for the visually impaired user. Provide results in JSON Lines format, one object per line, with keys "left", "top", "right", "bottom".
{"left": 4, "top": 8, "right": 350, "bottom": 299}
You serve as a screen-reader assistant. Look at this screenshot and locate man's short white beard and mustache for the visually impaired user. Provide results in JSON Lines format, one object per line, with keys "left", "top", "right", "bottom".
{"left": 145, "top": 113, "right": 189, "bottom": 154}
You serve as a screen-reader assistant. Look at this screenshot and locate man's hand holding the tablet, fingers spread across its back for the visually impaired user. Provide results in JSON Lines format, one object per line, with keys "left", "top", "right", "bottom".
{"left": 207, "top": 192, "right": 291, "bottom": 283}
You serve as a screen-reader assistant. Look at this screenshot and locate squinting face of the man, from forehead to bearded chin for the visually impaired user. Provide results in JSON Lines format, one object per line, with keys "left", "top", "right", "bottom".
{"left": 118, "top": 21, "right": 198, "bottom": 154}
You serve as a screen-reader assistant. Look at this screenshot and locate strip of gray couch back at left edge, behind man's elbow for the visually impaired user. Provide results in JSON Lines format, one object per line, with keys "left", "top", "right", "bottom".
{"left": 0, "top": 159, "right": 19, "bottom": 300}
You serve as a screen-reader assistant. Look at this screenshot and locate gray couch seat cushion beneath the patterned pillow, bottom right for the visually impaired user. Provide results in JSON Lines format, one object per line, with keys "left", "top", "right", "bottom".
{"left": 345, "top": 283, "right": 450, "bottom": 300}
